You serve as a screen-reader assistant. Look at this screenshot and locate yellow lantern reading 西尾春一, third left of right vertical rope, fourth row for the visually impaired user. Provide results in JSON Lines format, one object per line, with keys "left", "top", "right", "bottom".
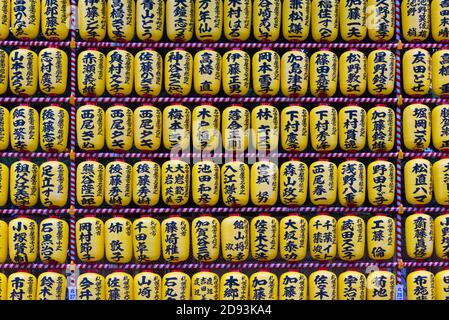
{"left": 309, "top": 160, "right": 338, "bottom": 205}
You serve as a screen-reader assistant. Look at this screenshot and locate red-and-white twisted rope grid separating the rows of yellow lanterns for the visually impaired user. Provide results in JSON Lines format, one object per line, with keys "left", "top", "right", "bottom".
{"left": 0, "top": 0, "right": 449, "bottom": 300}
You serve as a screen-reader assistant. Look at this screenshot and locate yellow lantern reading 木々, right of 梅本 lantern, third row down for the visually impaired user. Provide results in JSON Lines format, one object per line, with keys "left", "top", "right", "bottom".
{"left": 192, "top": 104, "right": 221, "bottom": 151}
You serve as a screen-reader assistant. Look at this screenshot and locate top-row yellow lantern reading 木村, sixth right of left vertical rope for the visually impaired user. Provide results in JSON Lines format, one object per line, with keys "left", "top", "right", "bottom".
{"left": 223, "top": 0, "right": 252, "bottom": 41}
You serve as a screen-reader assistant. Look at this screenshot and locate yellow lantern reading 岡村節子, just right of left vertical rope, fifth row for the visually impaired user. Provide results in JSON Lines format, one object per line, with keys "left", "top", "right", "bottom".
{"left": 75, "top": 217, "right": 105, "bottom": 262}
